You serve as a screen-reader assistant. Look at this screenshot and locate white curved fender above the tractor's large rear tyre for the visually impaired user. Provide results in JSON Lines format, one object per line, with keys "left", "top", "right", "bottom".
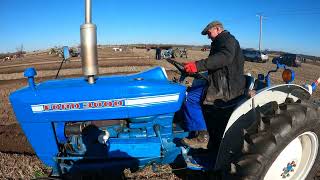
{"left": 215, "top": 84, "right": 311, "bottom": 170}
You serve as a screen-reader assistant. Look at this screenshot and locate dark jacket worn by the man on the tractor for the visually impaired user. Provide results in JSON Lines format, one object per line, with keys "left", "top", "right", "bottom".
{"left": 196, "top": 31, "right": 245, "bottom": 104}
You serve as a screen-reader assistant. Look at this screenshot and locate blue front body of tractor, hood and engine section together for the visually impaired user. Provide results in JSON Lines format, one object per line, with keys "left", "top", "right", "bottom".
{"left": 10, "top": 67, "right": 186, "bottom": 174}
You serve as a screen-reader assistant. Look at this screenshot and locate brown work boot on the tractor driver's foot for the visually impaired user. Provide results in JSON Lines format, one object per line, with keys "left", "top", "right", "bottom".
{"left": 181, "top": 130, "right": 209, "bottom": 149}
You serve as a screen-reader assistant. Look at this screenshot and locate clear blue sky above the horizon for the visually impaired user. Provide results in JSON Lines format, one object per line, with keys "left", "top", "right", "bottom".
{"left": 0, "top": 0, "right": 320, "bottom": 56}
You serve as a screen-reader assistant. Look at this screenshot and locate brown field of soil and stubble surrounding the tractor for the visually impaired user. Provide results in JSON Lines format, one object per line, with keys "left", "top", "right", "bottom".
{"left": 0, "top": 48, "right": 320, "bottom": 179}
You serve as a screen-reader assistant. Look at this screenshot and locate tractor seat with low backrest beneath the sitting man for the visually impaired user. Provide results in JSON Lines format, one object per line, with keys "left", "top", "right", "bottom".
{"left": 213, "top": 75, "right": 255, "bottom": 109}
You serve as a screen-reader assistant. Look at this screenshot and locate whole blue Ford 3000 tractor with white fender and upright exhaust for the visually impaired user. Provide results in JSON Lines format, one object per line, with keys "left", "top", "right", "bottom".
{"left": 10, "top": 0, "right": 320, "bottom": 180}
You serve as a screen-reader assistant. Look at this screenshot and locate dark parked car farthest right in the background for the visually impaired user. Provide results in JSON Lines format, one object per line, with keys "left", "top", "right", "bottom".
{"left": 272, "top": 54, "right": 304, "bottom": 67}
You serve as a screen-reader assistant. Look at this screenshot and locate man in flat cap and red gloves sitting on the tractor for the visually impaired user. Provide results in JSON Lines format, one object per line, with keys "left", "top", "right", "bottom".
{"left": 182, "top": 21, "right": 245, "bottom": 149}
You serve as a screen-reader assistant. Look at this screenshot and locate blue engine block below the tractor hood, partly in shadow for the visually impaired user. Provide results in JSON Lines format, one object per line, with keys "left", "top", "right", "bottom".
{"left": 54, "top": 114, "right": 173, "bottom": 159}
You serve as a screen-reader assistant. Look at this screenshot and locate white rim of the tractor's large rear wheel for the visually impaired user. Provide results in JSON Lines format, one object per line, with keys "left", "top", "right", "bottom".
{"left": 264, "top": 131, "right": 319, "bottom": 180}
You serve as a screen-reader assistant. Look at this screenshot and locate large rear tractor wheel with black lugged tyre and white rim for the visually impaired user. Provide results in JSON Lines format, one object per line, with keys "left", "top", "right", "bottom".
{"left": 224, "top": 99, "right": 320, "bottom": 180}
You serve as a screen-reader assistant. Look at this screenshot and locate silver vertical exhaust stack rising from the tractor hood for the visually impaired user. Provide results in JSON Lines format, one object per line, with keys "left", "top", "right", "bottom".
{"left": 80, "top": 0, "right": 98, "bottom": 84}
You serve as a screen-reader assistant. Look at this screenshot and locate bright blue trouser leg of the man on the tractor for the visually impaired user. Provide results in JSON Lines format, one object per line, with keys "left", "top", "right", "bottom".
{"left": 182, "top": 85, "right": 207, "bottom": 131}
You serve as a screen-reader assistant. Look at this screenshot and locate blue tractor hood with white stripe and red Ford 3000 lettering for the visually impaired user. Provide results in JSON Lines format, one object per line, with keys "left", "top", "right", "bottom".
{"left": 10, "top": 67, "right": 186, "bottom": 122}
